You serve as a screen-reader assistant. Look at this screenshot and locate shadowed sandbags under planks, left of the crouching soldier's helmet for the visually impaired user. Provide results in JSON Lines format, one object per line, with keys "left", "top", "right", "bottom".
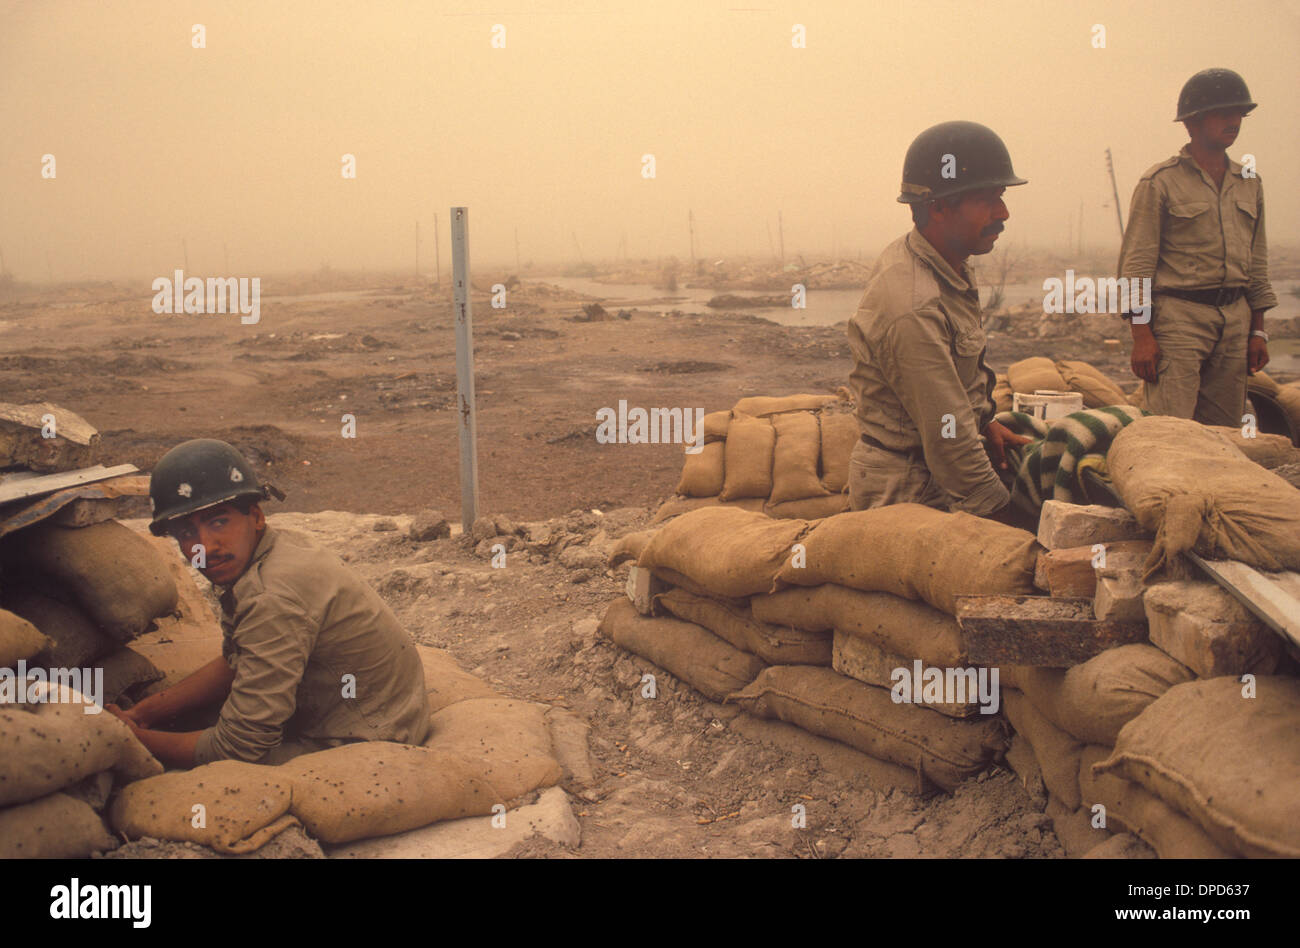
{"left": 0, "top": 520, "right": 177, "bottom": 706}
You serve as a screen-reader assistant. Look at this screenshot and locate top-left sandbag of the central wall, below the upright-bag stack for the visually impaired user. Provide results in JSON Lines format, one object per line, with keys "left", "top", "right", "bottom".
{"left": 637, "top": 507, "right": 806, "bottom": 598}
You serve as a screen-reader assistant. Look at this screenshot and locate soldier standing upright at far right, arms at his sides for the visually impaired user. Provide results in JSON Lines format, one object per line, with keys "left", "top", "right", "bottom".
{"left": 1119, "top": 69, "right": 1278, "bottom": 425}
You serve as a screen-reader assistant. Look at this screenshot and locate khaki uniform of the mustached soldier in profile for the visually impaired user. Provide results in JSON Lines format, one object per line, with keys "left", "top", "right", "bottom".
{"left": 849, "top": 228, "right": 1010, "bottom": 515}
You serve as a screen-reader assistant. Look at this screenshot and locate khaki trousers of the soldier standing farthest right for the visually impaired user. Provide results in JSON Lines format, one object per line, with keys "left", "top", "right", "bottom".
{"left": 1147, "top": 295, "right": 1251, "bottom": 427}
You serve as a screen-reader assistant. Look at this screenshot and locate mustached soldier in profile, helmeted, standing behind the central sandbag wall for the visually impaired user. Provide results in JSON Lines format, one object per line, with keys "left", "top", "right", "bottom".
{"left": 849, "top": 122, "right": 1030, "bottom": 518}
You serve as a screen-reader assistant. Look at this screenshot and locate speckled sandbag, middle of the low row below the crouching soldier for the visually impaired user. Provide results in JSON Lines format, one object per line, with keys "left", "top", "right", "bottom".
{"left": 284, "top": 741, "right": 506, "bottom": 843}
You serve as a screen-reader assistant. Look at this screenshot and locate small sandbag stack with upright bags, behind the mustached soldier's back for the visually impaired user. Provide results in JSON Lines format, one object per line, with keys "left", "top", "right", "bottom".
{"left": 655, "top": 395, "right": 858, "bottom": 523}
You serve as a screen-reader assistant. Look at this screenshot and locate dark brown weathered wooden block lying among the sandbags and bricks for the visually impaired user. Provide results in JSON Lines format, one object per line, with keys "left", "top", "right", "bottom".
{"left": 957, "top": 596, "right": 1147, "bottom": 668}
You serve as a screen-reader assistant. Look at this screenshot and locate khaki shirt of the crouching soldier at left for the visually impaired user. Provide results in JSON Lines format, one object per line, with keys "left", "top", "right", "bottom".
{"left": 194, "top": 527, "right": 429, "bottom": 763}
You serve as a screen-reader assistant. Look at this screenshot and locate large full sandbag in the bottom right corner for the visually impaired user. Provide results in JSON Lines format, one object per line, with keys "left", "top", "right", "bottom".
{"left": 1096, "top": 675, "right": 1300, "bottom": 858}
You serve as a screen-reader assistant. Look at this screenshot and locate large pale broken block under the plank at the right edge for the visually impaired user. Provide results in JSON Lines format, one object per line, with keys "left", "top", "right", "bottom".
{"left": 1143, "top": 580, "right": 1282, "bottom": 678}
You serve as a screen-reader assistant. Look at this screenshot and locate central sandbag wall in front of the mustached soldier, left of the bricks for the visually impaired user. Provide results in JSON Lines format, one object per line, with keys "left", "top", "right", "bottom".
{"left": 602, "top": 505, "right": 1036, "bottom": 788}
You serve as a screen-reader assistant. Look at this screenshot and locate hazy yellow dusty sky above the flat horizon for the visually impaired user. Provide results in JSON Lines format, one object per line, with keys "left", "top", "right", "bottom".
{"left": 0, "top": 0, "right": 1300, "bottom": 281}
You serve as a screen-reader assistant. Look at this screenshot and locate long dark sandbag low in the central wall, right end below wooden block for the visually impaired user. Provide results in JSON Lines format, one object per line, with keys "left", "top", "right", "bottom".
{"left": 728, "top": 665, "right": 1008, "bottom": 789}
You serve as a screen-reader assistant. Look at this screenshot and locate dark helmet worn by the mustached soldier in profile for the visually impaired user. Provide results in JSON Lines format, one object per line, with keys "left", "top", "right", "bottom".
{"left": 898, "top": 122, "right": 1030, "bottom": 204}
